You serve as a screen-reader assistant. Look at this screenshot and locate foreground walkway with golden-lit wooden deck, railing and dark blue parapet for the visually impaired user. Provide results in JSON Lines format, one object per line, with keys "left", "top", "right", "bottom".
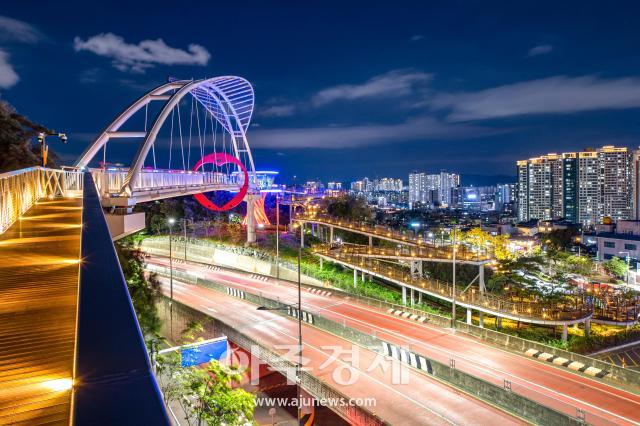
{"left": 0, "top": 167, "right": 169, "bottom": 425}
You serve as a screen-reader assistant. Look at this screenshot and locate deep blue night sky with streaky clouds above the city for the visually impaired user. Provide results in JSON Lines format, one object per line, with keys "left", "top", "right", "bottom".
{"left": 0, "top": 0, "right": 640, "bottom": 184}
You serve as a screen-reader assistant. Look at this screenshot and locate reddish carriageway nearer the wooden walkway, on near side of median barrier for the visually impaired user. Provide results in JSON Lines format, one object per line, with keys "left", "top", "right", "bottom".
{"left": 156, "top": 278, "right": 524, "bottom": 425}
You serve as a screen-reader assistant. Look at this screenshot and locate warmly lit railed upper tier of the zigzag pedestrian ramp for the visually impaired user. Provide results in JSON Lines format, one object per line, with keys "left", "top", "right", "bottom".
{"left": 293, "top": 212, "right": 493, "bottom": 261}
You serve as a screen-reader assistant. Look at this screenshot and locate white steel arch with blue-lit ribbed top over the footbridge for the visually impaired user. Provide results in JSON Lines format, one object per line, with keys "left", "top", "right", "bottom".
{"left": 76, "top": 76, "right": 257, "bottom": 195}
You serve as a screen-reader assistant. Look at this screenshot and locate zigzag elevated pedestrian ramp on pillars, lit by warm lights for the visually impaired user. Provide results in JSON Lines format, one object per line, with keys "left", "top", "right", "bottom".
{"left": 294, "top": 211, "right": 593, "bottom": 341}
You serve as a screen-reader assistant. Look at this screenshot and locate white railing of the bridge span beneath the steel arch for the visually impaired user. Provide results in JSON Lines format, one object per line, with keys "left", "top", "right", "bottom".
{"left": 91, "top": 168, "right": 244, "bottom": 195}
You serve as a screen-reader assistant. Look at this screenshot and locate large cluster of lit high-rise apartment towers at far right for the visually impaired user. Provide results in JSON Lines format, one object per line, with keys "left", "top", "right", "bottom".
{"left": 517, "top": 146, "right": 638, "bottom": 226}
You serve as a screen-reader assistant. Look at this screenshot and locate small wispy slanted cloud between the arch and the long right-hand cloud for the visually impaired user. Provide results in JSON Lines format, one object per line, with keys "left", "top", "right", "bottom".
{"left": 311, "top": 70, "right": 432, "bottom": 106}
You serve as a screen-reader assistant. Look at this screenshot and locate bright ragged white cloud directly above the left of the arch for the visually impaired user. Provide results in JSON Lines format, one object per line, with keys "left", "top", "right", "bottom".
{"left": 73, "top": 33, "right": 211, "bottom": 73}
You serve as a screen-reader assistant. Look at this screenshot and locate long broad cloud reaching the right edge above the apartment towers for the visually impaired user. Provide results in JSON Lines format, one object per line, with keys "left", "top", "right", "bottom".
{"left": 428, "top": 76, "right": 640, "bottom": 121}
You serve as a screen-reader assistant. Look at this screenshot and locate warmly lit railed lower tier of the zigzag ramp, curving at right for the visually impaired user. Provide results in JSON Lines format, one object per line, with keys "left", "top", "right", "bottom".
{"left": 314, "top": 247, "right": 593, "bottom": 322}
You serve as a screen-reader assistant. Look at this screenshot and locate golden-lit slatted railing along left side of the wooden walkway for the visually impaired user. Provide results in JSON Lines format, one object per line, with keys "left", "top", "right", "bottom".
{"left": 0, "top": 167, "right": 83, "bottom": 234}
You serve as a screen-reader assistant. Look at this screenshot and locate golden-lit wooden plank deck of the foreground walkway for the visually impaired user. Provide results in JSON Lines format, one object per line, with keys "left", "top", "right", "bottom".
{"left": 0, "top": 198, "right": 82, "bottom": 425}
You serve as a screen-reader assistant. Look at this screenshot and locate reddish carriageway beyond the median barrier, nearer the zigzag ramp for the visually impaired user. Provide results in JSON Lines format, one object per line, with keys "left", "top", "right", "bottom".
{"left": 149, "top": 257, "right": 640, "bottom": 424}
